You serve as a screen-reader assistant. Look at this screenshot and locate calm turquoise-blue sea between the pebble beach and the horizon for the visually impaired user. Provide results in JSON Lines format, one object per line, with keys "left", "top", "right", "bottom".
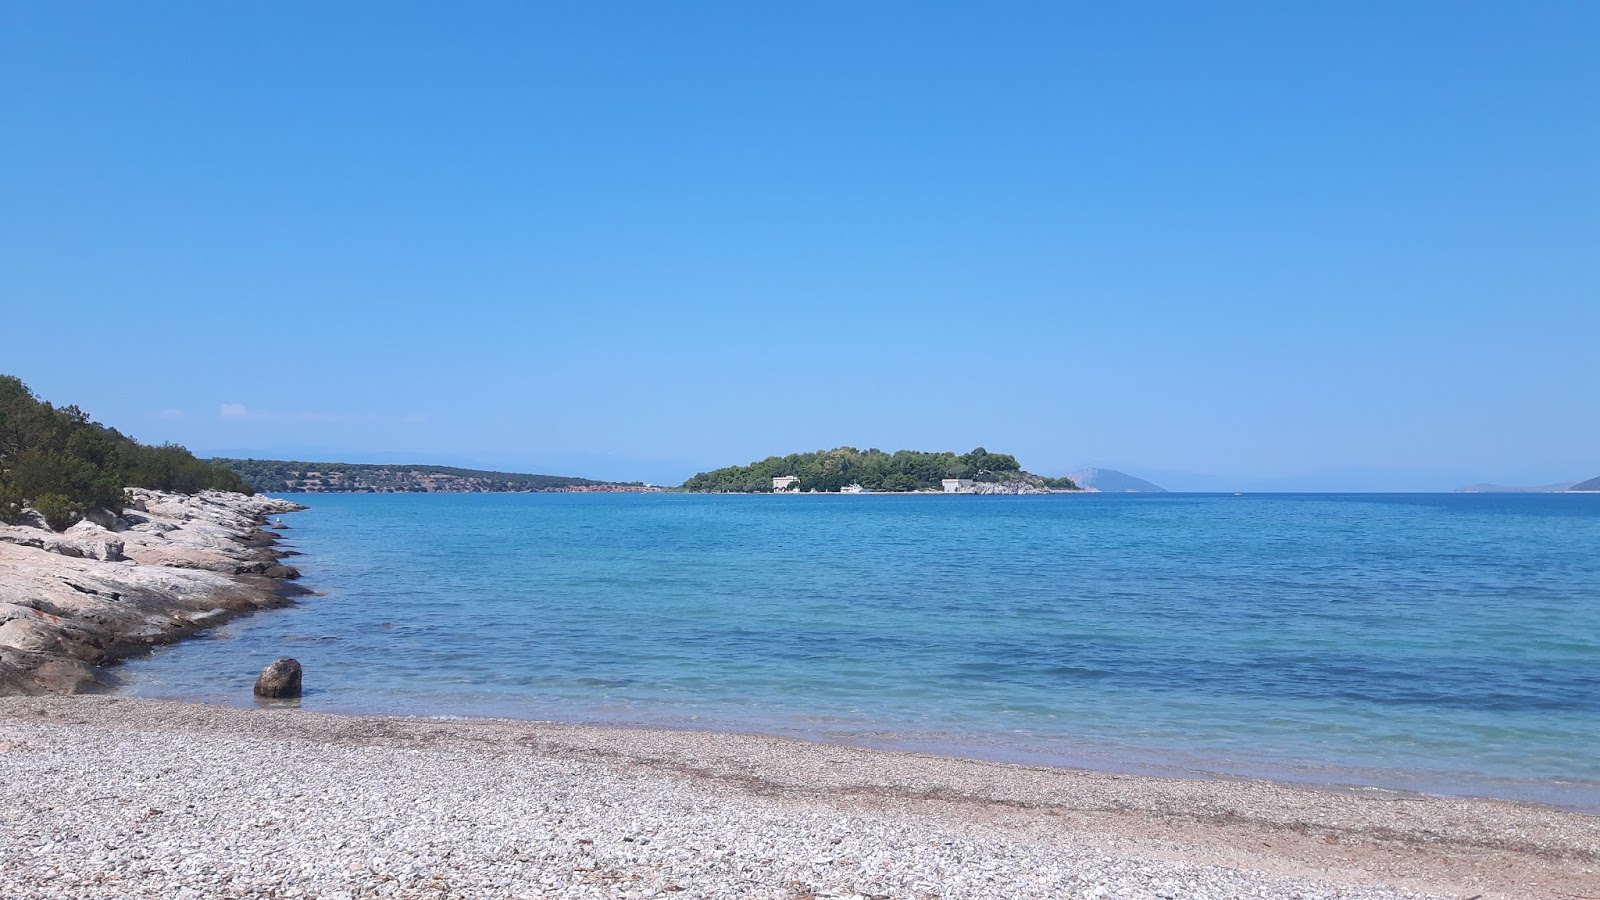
{"left": 122, "top": 495, "right": 1600, "bottom": 810}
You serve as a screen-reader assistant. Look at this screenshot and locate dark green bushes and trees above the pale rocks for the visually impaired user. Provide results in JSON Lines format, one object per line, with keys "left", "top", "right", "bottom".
{"left": 0, "top": 375, "right": 253, "bottom": 532}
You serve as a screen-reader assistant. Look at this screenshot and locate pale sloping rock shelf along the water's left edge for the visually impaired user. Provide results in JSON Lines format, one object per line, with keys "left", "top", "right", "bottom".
{"left": 0, "top": 488, "right": 304, "bottom": 695}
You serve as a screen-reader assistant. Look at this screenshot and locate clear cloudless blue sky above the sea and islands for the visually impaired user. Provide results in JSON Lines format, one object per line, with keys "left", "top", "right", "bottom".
{"left": 0, "top": 0, "right": 1600, "bottom": 490}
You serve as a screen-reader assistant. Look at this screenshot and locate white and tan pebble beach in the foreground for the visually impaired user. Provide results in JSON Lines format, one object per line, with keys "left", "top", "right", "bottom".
{"left": 0, "top": 697, "right": 1600, "bottom": 900}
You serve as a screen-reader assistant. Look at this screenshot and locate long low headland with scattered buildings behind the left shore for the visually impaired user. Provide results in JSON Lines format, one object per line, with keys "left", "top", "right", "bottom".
{"left": 211, "top": 456, "right": 656, "bottom": 493}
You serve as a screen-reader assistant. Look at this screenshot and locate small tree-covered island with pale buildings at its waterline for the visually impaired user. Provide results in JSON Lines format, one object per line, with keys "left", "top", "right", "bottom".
{"left": 680, "top": 447, "right": 1078, "bottom": 493}
